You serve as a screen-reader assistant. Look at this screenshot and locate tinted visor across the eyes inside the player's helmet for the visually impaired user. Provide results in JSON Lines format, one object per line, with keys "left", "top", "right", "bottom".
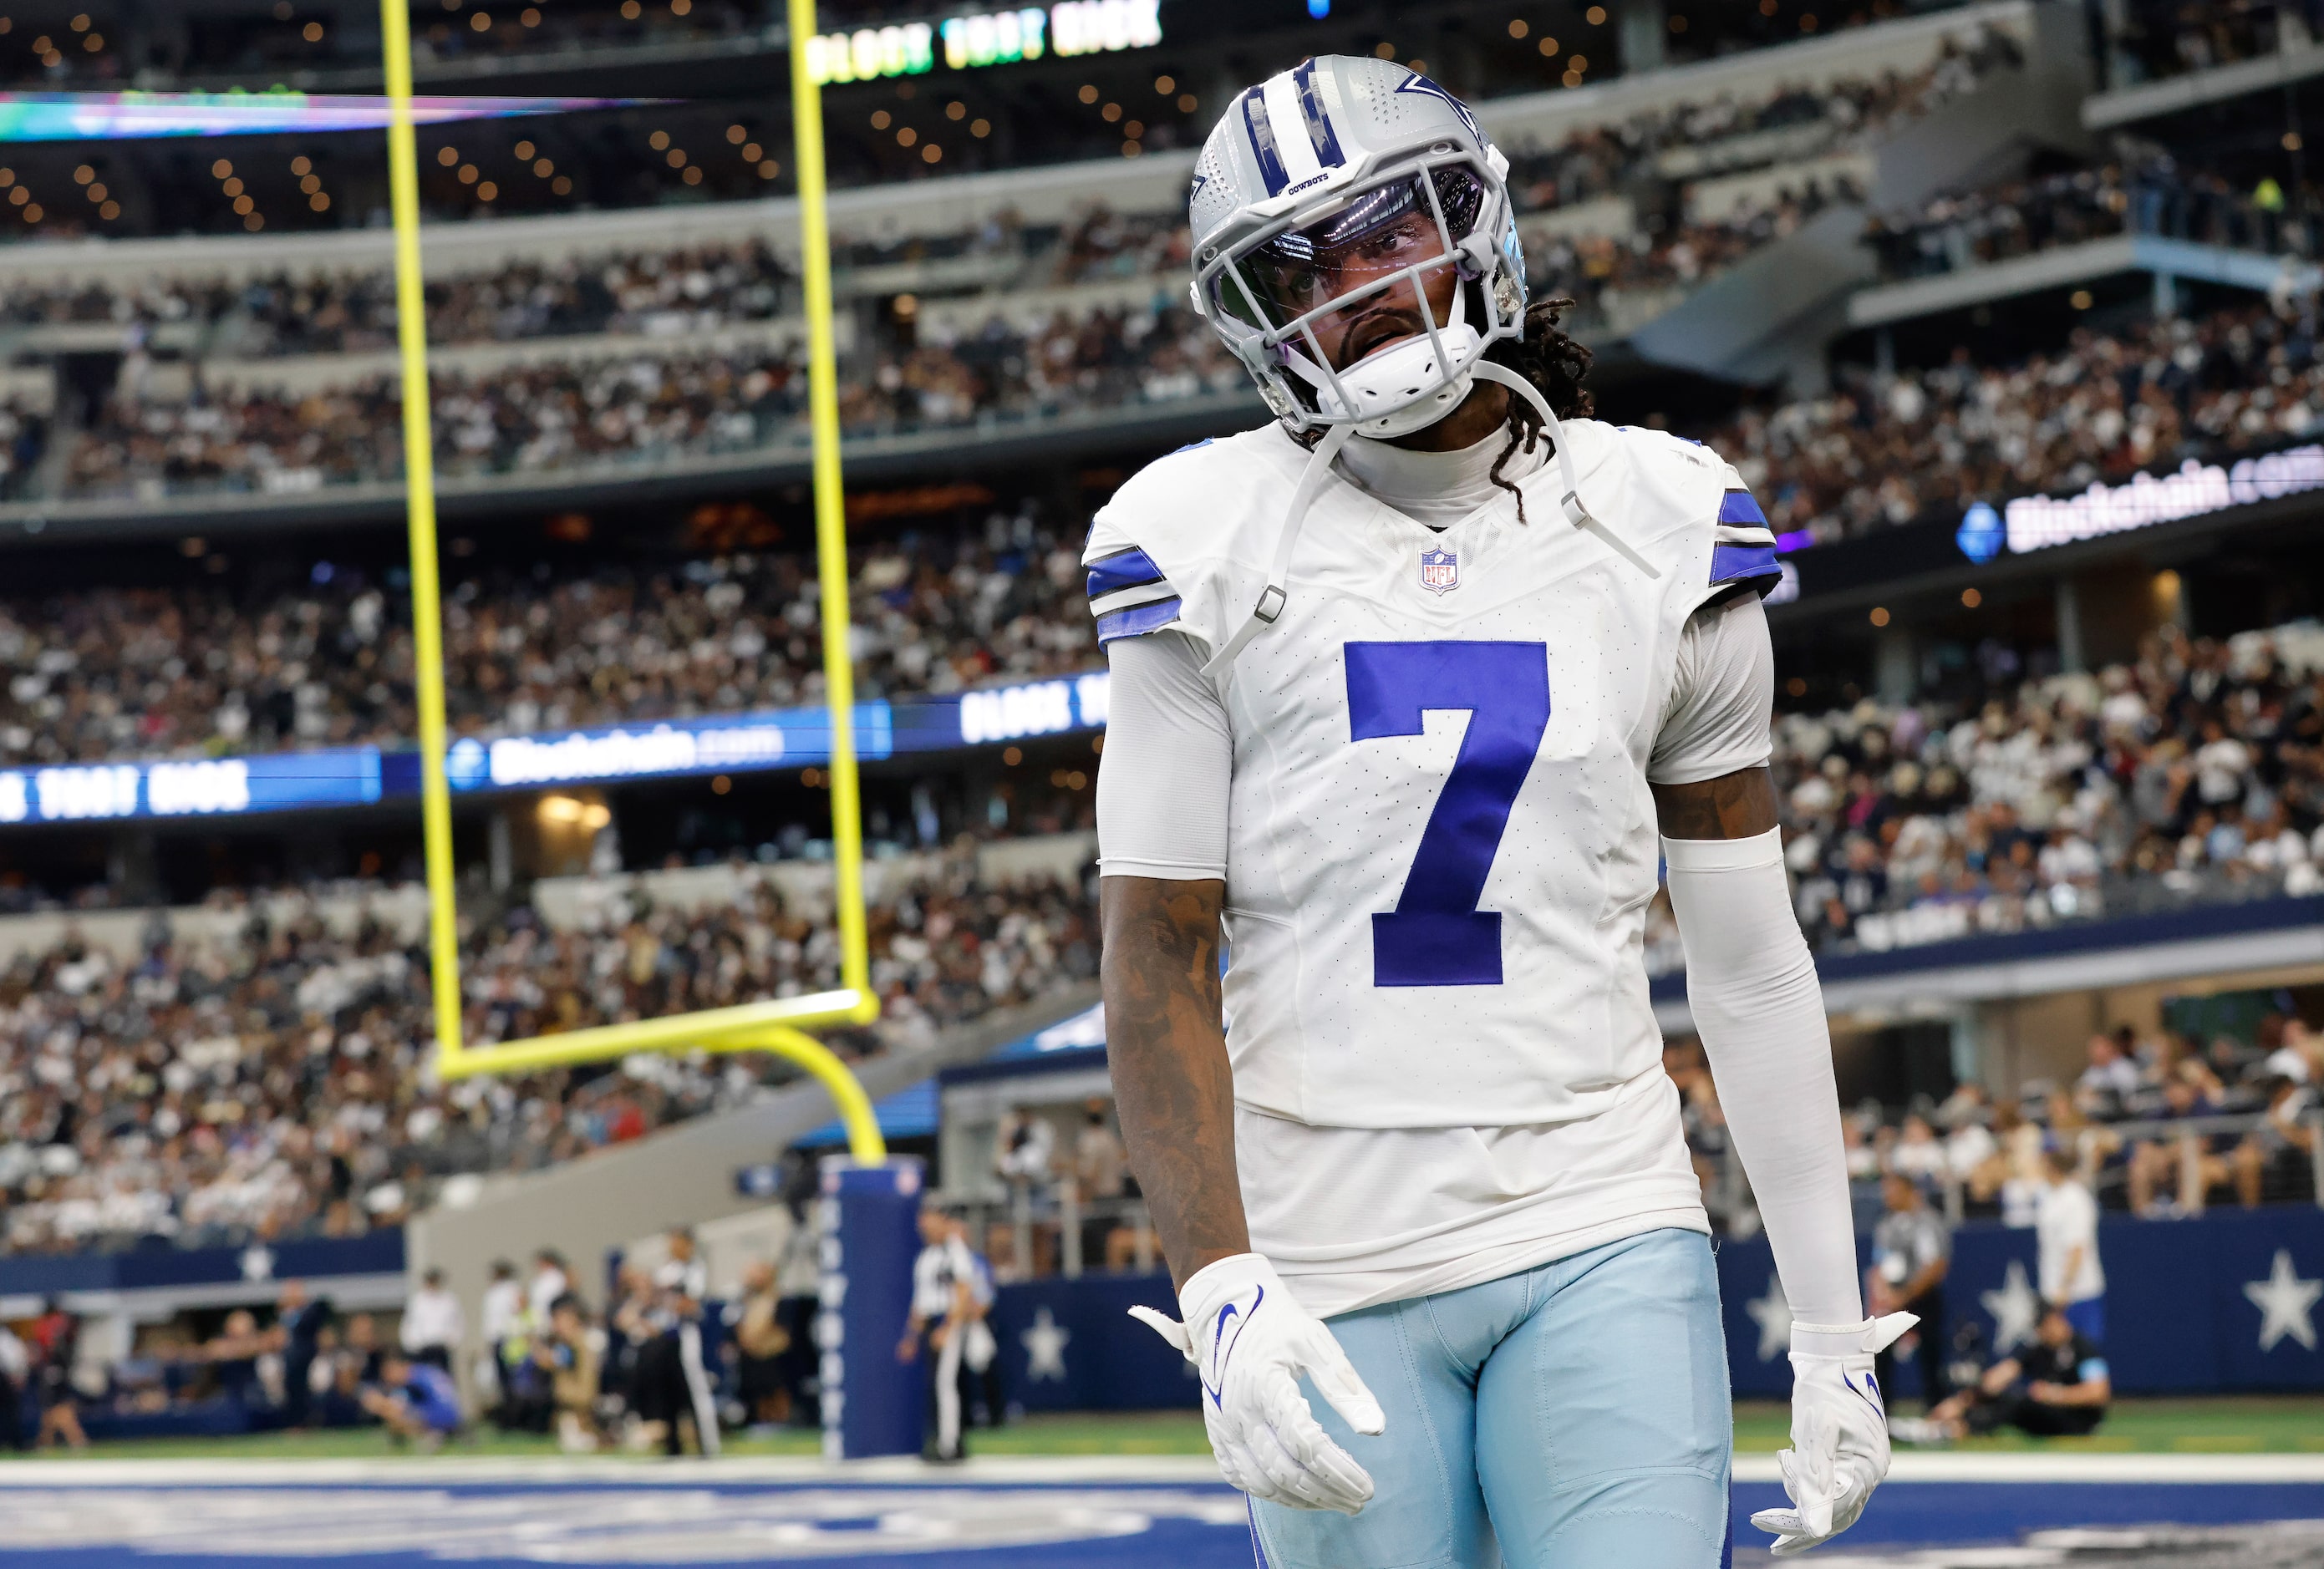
{"left": 1215, "top": 167, "right": 1485, "bottom": 328}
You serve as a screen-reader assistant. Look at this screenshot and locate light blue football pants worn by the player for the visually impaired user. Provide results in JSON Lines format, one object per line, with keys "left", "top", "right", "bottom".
{"left": 1250, "top": 1230, "right": 1734, "bottom": 1569}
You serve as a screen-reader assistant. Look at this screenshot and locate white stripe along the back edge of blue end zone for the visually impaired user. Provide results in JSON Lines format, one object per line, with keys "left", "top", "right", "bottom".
{"left": 0, "top": 1450, "right": 2324, "bottom": 1492}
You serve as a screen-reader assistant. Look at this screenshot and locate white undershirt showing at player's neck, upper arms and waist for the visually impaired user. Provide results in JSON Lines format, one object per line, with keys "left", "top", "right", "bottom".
{"left": 1097, "top": 583, "right": 1776, "bottom": 1316}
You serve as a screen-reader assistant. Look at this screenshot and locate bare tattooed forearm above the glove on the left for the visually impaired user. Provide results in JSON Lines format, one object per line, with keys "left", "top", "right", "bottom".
{"left": 1097, "top": 876, "right": 1250, "bottom": 1286}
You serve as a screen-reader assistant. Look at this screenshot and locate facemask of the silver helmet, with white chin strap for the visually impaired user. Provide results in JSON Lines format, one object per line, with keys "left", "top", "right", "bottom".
{"left": 1194, "top": 144, "right": 1524, "bottom": 437}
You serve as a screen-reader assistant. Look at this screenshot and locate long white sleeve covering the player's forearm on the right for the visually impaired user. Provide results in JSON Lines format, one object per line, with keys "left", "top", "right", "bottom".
{"left": 1661, "top": 836, "right": 1864, "bottom": 1353}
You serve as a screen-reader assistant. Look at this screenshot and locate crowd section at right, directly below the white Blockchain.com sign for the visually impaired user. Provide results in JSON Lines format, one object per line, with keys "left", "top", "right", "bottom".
{"left": 1648, "top": 623, "right": 2324, "bottom": 974}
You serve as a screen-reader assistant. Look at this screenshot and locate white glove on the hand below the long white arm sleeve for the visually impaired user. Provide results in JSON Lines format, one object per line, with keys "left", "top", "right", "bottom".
{"left": 1750, "top": 1313, "right": 1920, "bottom": 1557}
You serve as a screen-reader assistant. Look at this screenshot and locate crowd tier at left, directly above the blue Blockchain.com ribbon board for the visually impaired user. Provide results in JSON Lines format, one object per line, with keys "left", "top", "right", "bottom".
{"left": 0, "top": 514, "right": 1097, "bottom": 763}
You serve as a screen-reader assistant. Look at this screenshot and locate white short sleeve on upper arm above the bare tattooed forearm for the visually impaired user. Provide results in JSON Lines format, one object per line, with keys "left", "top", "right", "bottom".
{"left": 1097, "top": 632, "right": 1234, "bottom": 881}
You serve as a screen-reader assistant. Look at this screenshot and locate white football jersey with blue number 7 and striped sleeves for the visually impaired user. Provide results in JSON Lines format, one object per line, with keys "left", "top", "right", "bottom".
{"left": 1086, "top": 421, "right": 1777, "bottom": 1127}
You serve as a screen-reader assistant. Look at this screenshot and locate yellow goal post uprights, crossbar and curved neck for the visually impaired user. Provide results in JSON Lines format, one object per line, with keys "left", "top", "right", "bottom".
{"left": 379, "top": 0, "right": 887, "bottom": 1162}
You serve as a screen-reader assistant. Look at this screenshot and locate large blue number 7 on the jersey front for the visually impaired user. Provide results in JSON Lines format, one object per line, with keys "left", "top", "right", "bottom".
{"left": 1348, "top": 642, "right": 1550, "bottom": 986}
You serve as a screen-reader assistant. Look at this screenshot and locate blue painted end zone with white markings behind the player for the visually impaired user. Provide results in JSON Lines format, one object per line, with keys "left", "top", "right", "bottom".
{"left": 0, "top": 1457, "right": 2324, "bottom": 1569}
